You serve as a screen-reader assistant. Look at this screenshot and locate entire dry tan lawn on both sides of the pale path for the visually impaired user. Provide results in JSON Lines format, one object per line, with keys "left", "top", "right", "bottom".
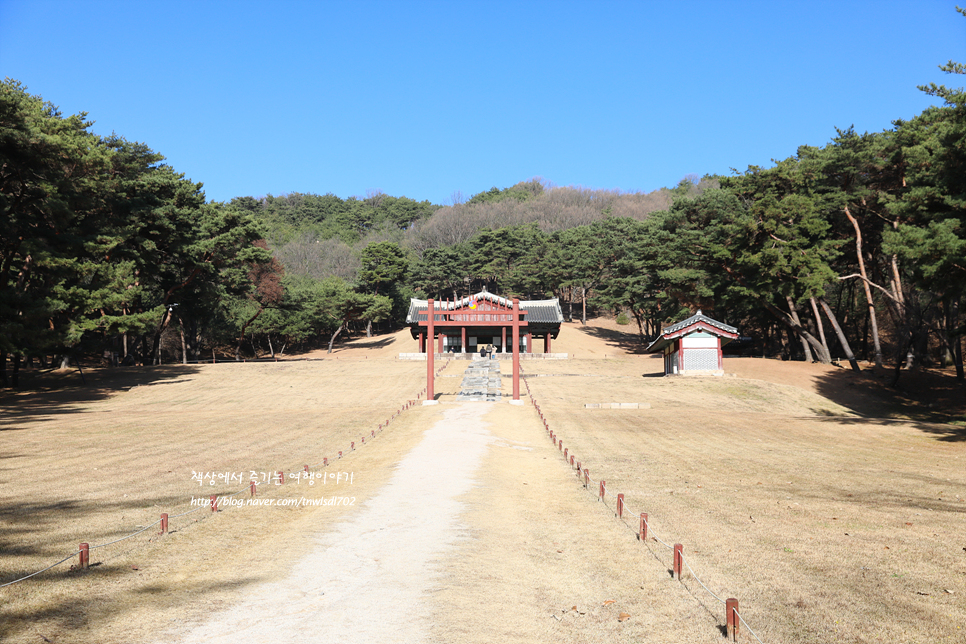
{"left": 0, "top": 321, "right": 966, "bottom": 643}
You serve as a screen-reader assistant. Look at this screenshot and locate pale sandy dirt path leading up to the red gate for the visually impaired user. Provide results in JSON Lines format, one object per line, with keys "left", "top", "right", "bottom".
{"left": 169, "top": 403, "right": 492, "bottom": 644}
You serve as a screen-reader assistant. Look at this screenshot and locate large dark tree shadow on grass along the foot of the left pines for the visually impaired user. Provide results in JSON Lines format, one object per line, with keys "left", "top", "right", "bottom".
{"left": 0, "top": 365, "right": 199, "bottom": 431}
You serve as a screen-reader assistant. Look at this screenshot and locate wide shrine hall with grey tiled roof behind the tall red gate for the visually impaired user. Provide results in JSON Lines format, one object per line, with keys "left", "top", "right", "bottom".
{"left": 406, "top": 291, "right": 563, "bottom": 354}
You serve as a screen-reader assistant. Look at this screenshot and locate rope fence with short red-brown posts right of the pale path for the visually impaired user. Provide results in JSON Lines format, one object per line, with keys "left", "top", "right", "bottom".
{"left": 521, "top": 373, "right": 764, "bottom": 644}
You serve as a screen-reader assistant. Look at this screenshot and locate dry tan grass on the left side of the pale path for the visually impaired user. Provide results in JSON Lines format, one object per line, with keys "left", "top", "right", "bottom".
{"left": 0, "top": 360, "right": 458, "bottom": 642}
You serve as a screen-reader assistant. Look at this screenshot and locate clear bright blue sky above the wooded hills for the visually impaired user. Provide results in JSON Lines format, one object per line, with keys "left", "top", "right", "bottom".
{"left": 0, "top": 0, "right": 966, "bottom": 204}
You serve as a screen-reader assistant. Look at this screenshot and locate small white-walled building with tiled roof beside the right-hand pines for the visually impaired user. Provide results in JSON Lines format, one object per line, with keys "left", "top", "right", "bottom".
{"left": 647, "top": 310, "right": 738, "bottom": 376}
